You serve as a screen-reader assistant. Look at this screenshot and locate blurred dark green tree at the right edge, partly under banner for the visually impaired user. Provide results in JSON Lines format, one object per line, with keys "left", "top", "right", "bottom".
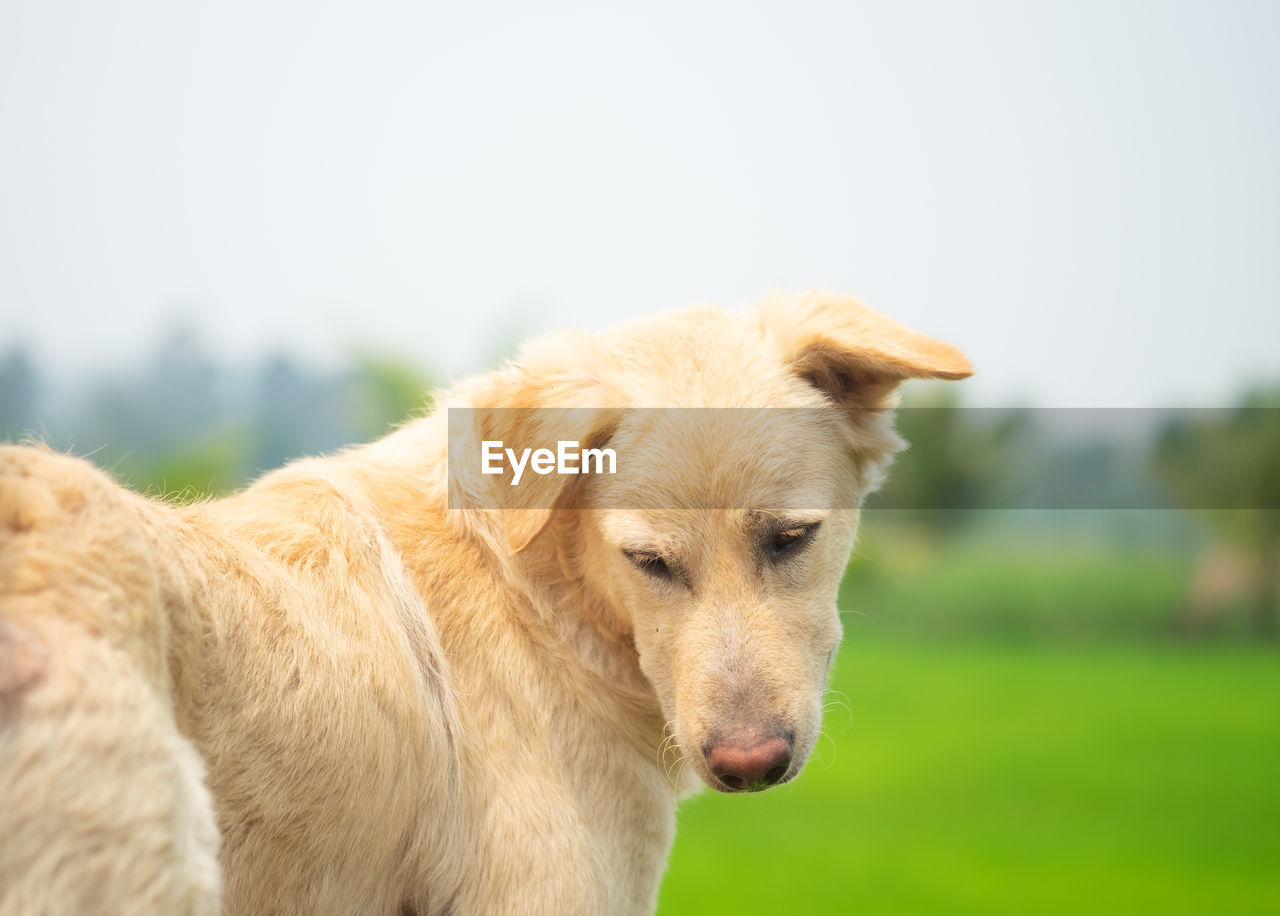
{"left": 1153, "top": 386, "right": 1280, "bottom": 638}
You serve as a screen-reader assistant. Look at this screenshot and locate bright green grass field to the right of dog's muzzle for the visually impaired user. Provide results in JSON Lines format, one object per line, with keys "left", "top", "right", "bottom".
{"left": 659, "top": 637, "right": 1280, "bottom": 916}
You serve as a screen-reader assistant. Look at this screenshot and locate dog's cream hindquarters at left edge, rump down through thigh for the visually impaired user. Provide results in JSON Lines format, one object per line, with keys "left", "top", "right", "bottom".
{"left": 0, "top": 446, "right": 219, "bottom": 916}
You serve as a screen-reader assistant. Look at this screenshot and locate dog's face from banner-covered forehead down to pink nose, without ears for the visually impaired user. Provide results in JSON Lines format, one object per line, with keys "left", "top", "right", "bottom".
{"left": 580, "top": 408, "right": 858, "bottom": 792}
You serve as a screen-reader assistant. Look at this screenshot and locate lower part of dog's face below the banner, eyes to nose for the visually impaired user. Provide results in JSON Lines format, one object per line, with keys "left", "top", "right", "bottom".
{"left": 602, "top": 510, "right": 855, "bottom": 792}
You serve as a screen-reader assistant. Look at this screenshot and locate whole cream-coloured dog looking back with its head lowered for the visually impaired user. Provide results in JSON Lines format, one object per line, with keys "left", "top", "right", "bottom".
{"left": 0, "top": 293, "right": 973, "bottom": 916}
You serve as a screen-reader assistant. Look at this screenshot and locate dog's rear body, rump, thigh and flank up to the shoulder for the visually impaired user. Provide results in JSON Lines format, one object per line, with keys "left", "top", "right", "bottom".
{"left": 0, "top": 448, "right": 461, "bottom": 916}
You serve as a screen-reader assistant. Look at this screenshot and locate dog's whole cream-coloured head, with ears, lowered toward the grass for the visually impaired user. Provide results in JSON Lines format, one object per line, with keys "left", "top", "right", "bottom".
{"left": 460, "top": 294, "right": 972, "bottom": 792}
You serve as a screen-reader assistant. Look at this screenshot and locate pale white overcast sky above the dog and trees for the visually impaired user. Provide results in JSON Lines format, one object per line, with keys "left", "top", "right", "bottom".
{"left": 0, "top": 0, "right": 1280, "bottom": 406}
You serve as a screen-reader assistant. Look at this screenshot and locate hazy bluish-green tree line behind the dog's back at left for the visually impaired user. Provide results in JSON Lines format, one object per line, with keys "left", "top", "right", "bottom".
{"left": 0, "top": 330, "right": 430, "bottom": 498}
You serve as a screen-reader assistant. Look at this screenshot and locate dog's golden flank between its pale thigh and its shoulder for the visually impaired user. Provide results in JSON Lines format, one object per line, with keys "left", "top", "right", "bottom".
{"left": 170, "top": 458, "right": 465, "bottom": 915}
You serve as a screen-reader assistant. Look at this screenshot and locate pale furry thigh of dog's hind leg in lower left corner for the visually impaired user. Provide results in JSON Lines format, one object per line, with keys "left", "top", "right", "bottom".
{"left": 0, "top": 620, "right": 219, "bottom": 916}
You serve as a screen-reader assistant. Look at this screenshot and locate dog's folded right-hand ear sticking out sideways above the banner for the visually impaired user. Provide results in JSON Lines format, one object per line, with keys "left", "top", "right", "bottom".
{"left": 760, "top": 293, "right": 973, "bottom": 408}
